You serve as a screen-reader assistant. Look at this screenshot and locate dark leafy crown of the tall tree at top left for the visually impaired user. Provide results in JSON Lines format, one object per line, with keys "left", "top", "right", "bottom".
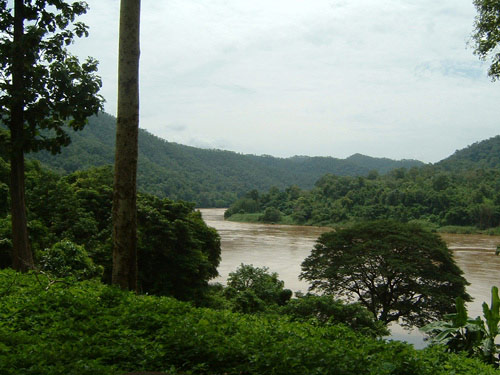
{"left": 0, "top": 0, "right": 104, "bottom": 154}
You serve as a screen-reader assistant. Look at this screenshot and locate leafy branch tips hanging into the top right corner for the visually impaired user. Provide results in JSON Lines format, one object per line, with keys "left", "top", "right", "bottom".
{"left": 472, "top": 0, "right": 500, "bottom": 81}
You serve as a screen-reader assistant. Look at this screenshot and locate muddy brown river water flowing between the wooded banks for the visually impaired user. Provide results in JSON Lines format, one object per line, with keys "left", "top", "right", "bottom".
{"left": 200, "top": 208, "right": 500, "bottom": 347}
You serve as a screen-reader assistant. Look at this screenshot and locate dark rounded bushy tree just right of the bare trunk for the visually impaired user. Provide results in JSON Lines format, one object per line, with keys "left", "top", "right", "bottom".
{"left": 137, "top": 194, "right": 220, "bottom": 301}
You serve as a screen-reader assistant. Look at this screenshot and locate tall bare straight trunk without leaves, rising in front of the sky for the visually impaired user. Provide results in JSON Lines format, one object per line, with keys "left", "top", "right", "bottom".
{"left": 112, "top": 0, "right": 141, "bottom": 290}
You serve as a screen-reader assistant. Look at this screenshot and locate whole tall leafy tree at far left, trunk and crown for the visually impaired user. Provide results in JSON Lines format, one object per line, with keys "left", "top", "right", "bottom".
{"left": 0, "top": 0, "right": 103, "bottom": 271}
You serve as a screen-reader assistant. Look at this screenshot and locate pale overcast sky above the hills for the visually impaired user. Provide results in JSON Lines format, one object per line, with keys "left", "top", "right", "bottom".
{"left": 73, "top": 0, "right": 500, "bottom": 162}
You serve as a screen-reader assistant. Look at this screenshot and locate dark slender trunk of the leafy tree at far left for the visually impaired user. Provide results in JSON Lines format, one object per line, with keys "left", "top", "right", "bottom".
{"left": 10, "top": 0, "right": 33, "bottom": 272}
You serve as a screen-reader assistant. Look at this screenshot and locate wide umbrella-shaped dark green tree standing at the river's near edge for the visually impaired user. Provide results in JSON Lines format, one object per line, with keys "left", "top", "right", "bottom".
{"left": 300, "top": 220, "right": 470, "bottom": 327}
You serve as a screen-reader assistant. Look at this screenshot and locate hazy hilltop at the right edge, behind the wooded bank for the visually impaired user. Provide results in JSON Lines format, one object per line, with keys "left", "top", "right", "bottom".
{"left": 436, "top": 135, "right": 500, "bottom": 171}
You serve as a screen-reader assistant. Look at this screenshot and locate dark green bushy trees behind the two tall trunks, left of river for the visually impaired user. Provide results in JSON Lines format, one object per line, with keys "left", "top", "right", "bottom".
{"left": 0, "top": 159, "right": 220, "bottom": 300}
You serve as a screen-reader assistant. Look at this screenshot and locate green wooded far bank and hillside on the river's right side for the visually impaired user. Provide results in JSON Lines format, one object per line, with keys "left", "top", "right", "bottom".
{"left": 225, "top": 137, "right": 500, "bottom": 233}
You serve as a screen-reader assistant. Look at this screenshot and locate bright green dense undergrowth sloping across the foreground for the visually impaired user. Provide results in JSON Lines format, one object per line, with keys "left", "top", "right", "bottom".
{"left": 0, "top": 270, "right": 498, "bottom": 375}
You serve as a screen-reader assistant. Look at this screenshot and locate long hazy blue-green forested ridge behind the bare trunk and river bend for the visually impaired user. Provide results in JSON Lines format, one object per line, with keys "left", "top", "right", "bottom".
{"left": 30, "top": 113, "right": 423, "bottom": 207}
